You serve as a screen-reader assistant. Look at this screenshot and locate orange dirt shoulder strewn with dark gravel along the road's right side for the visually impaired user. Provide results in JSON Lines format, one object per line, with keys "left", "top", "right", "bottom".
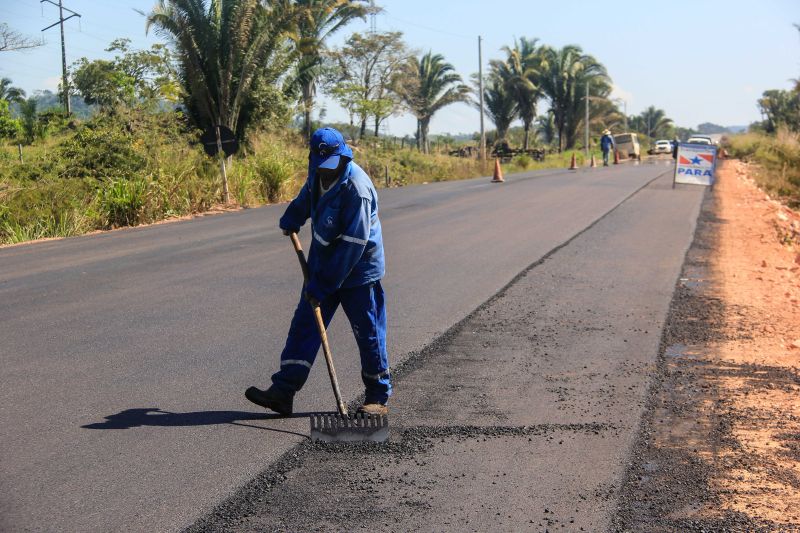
{"left": 613, "top": 161, "right": 800, "bottom": 531}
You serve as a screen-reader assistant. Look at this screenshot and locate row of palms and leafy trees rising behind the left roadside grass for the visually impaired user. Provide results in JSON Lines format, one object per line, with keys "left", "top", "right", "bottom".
{"left": 0, "top": 0, "right": 688, "bottom": 152}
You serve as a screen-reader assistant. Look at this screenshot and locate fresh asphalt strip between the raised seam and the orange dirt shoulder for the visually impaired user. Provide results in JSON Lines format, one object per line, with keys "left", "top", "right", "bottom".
{"left": 189, "top": 171, "right": 702, "bottom": 531}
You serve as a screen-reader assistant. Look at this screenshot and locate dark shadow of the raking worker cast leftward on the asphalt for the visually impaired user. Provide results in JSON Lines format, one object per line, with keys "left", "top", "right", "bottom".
{"left": 81, "top": 407, "right": 311, "bottom": 437}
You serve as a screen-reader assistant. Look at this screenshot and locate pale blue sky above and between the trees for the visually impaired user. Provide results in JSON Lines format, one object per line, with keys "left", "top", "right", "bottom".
{"left": 0, "top": 0, "right": 800, "bottom": 135}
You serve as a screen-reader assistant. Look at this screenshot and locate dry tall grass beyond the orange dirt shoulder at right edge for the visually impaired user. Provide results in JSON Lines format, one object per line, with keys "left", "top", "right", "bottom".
{"left": 725, "top": 128, "right": 800, "bottom": 209}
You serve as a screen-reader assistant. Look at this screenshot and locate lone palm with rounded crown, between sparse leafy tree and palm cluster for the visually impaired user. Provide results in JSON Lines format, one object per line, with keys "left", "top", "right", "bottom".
{"left": 397, "top": 52, "right": 469, "bottom": 154}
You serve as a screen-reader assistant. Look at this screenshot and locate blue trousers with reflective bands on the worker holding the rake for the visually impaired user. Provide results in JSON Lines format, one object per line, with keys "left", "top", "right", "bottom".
{"left": 272, "top": 281, "right": 392, "bottom": 404}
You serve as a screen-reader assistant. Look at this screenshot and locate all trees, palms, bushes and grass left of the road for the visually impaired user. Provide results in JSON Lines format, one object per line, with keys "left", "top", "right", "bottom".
{"left": 0, "top": 0, "right": 700, "bottom": 244}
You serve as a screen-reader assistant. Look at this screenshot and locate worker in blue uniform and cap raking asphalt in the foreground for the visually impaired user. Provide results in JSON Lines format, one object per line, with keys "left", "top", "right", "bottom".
{"left": 245, "top": 128, "right": 392, "bottom": 415}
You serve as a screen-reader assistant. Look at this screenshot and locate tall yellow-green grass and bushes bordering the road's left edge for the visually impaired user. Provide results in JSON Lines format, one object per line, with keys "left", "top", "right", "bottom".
{"left": 0, "top": 114, "right": 569, "bottom": 244}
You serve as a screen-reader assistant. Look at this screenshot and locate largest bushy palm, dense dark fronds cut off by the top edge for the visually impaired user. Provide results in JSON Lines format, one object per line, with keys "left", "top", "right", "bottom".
{"left": 146, "top": 0, "right": 295, "bottom": 138}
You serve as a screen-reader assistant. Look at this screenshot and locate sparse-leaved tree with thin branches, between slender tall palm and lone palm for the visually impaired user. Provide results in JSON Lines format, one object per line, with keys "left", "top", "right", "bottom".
{"left": 326, "top": 32, "right": 408, "bottom": 137}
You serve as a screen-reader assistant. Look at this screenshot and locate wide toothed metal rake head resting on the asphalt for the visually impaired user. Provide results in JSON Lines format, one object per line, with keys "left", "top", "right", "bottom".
{"left": 311, "top": 413, "right": 389, "bottom": 442}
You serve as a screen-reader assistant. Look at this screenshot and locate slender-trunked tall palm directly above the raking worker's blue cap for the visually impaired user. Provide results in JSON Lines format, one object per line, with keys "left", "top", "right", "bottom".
{"left": 294, "top": 0, "right": 369, "bottom": 139}
